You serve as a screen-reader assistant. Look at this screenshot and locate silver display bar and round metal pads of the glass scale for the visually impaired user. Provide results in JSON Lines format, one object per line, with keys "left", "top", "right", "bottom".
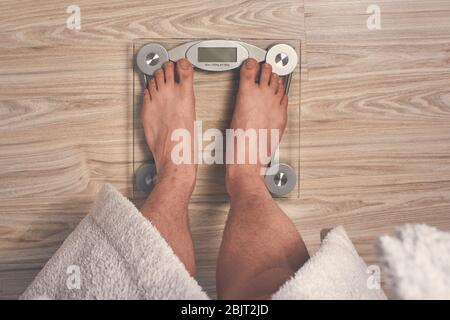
{"left": 135, "top": 40, "right": 298, "bottom": 196}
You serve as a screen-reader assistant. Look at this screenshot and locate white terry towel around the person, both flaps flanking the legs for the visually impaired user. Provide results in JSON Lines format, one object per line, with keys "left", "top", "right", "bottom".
{"left": 21, "top": 185, "right": 446, "bottom": 299}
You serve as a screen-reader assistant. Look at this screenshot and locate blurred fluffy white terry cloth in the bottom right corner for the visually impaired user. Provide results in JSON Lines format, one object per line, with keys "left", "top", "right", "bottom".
{"left": 378, "top": 225, "right": 450, "bottom": 299}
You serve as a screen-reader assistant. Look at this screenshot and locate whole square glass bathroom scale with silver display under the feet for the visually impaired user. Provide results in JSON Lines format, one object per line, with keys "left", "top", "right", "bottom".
{"left": 132, "top": 38, "right": 301, "bottom": 202}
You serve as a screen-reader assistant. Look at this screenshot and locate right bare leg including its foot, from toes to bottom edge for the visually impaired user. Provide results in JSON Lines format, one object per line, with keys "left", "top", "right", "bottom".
{"left": 217, "top": 59, "right": 309, "bottom": 299}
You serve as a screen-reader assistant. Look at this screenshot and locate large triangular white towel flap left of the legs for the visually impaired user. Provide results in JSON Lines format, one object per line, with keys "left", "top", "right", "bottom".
{"left": 22, "top": 185, "right": 208, "bottom": 299}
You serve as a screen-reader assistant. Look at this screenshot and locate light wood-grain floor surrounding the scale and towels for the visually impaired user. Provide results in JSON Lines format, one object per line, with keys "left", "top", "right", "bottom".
{"left": 0, "top": 0, "right": 450, "bottom": 298}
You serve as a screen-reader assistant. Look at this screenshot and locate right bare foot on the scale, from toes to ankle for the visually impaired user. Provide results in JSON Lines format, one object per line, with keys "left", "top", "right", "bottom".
{"left": 226, "top": 59, "right": 288, "bottom": 195}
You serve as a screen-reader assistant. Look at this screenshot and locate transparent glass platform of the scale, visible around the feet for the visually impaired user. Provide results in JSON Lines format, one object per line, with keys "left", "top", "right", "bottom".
{"left": 132, "top": 39, "right": 301, "bottom": 202}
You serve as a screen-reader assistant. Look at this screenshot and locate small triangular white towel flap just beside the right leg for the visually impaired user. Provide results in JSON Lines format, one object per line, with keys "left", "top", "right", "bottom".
{"left": 273, "top": 227, "right": 386, "bottom": 300}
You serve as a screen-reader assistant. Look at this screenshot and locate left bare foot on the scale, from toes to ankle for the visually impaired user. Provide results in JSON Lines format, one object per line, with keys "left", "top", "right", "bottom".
{"left": 141, "top": 59, "right": 196, "bottom": 190}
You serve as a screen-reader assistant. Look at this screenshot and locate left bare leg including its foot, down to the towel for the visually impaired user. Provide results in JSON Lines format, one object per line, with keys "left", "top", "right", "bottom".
{"left": 141, "top": 59, "right": 196, "bottom": 275}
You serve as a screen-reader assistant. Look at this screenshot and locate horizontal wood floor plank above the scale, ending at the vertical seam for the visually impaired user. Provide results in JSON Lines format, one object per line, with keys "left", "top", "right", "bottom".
{"left": 0, "top": 0, "right": 304, "bottom": 47}
